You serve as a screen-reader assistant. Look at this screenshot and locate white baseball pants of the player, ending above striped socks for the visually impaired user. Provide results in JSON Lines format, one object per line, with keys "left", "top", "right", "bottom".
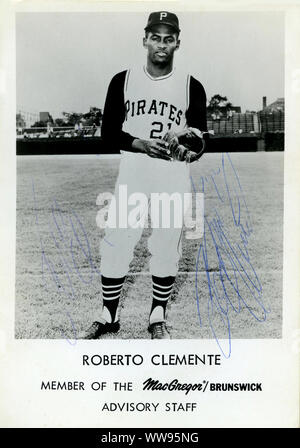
{"left": 100, "top": 152, "right": 191, "bottom": 278}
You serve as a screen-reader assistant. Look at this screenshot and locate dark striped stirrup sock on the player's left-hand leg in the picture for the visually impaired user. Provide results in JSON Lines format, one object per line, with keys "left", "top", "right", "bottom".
{"left": 101, "top": 275, "right": 125, "bottom": 323}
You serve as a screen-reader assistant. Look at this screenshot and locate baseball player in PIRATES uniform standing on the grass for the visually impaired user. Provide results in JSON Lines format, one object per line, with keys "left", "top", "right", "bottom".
{"left": 80, "top": 11, "right": 207, "bottom": 339}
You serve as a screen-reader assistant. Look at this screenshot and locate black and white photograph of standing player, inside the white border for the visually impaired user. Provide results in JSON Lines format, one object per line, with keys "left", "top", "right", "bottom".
{"left": 15, "top": 10, "right": 285, "bottom": 350}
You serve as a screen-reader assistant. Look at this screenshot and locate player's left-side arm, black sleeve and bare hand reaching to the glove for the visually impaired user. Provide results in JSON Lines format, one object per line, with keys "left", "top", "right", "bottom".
{"left": 101, "top": 70, "right": 170, "bottom": 160}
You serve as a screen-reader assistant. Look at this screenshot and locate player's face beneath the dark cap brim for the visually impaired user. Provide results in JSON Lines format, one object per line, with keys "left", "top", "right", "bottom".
{"left": 143, "top": 25, "right": 180, "bottom": 65}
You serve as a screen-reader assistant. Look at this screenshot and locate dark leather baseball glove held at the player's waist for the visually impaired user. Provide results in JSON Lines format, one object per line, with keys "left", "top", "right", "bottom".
{"left": 163, "top": 128, "right": 205, "bottom": 163}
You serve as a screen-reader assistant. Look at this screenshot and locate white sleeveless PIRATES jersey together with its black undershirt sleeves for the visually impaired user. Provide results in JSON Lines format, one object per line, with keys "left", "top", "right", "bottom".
{"left": 101, "top": 66, "right": 207, "bottom": 153}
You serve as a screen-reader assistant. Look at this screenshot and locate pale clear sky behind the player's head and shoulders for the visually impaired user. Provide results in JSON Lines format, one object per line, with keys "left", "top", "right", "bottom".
{"left": 16, "top": 12, "right": 284, "bottom": 118}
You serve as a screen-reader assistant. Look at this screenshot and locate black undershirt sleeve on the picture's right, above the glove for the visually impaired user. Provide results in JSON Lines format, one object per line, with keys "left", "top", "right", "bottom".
{"left": 186, "top": 76, "right": 208, "bottom": 146}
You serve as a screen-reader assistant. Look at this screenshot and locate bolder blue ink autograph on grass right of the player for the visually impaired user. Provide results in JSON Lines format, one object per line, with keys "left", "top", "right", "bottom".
{"left": 191, "top": 154, "right": 269, "bottom": 358}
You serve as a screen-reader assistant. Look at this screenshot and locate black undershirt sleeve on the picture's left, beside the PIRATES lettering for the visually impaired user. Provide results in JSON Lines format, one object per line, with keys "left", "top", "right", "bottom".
{"left": 101, "top": 70, "right": 137, "bottom": 152}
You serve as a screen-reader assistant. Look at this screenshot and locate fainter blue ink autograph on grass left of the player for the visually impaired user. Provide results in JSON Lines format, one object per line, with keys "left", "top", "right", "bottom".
{"left": 32, "top": 180, "right": 101, "bottom": 345}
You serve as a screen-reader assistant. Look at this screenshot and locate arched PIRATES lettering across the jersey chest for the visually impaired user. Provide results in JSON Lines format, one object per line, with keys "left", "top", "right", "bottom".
{"left": 125, "top": 99, "right": 183, "bottom": 126}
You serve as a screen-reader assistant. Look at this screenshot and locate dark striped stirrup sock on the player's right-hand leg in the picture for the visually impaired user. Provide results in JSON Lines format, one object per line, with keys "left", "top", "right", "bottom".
{"left": 149, "top": 275, "right": 175, "bottom": 325}
